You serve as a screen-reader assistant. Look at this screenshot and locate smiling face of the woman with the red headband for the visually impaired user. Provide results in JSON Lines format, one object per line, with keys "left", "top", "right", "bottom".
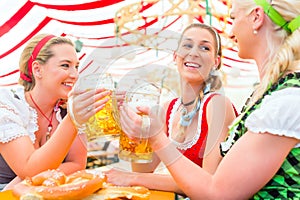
{"left": 34, "top": 43, "right": 79, "bottom": 99}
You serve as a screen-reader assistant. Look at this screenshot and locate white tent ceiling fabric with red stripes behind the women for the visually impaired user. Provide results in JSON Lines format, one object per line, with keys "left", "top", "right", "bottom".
{"left": 0, "top": 0, "right": 257, "bottom": 86}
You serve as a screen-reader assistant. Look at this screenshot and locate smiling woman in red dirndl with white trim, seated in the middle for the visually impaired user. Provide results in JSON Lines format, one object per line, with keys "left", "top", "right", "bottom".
{"left": 106, "top": 23, "right": 236, "bottom": 194}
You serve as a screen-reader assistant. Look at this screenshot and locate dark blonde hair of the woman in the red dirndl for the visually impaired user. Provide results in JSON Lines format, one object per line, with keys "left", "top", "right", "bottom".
{"left": 178, "top": 23, "right": 222, "bottom": 91}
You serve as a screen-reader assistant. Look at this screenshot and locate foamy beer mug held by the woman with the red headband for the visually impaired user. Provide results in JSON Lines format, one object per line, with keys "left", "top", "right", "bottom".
{"left": 71, "top": 73, "right": 121, "bottom": 141}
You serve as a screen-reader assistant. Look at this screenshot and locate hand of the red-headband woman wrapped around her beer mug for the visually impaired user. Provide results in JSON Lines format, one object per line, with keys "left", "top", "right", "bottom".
{"left": 68, "top": 88, "right": 111, "bottom": 126}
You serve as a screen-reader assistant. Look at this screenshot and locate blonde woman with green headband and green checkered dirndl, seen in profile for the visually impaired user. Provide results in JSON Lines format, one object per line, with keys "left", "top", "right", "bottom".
{"left": 113, "top": 0, "right": 300, "bottom": 200}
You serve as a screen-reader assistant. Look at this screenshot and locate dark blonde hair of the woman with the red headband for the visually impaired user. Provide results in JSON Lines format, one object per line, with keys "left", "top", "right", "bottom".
{"left": 19, "top": 34, "right": 75, "bottom": 91}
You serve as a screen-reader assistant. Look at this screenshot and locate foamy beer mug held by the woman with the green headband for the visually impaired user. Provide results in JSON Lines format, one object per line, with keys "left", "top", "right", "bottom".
{"left": 119, "top": 83, "right": 161, "bottom": 163}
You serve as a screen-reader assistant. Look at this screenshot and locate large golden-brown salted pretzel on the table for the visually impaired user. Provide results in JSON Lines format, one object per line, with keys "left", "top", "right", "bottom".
{"left": 13, "top": 170, "right": 106, "bottom": 200}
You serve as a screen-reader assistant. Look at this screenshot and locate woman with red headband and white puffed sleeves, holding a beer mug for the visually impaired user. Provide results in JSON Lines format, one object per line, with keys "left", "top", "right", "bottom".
{"left": 0, "top": 34, "right": 107, "bottom": 188}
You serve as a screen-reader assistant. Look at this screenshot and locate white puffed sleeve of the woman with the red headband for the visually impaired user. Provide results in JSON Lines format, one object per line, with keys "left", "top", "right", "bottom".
{"left": 0, "top": 86, "right": 38, "bottom": 143}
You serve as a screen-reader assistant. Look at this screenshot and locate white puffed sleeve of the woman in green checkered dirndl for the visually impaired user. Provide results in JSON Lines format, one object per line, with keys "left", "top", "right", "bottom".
{"left": 245, "top": 87, "right": 300, "bottom": 147}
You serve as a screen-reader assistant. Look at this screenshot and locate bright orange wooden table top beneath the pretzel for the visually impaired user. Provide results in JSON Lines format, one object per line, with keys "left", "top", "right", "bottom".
{"left": 0, "top": 190, "right": 175, "bottom": 200}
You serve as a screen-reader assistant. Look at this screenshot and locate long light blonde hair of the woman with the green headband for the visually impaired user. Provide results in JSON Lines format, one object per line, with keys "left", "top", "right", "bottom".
{"left": 236, "top": 0, "right": 300, "bottom": 103}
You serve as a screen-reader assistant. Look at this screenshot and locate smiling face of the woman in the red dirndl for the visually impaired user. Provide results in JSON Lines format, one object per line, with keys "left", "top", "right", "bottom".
{"left": 175, "top": 27, "right": 220, "bottom": 84}
